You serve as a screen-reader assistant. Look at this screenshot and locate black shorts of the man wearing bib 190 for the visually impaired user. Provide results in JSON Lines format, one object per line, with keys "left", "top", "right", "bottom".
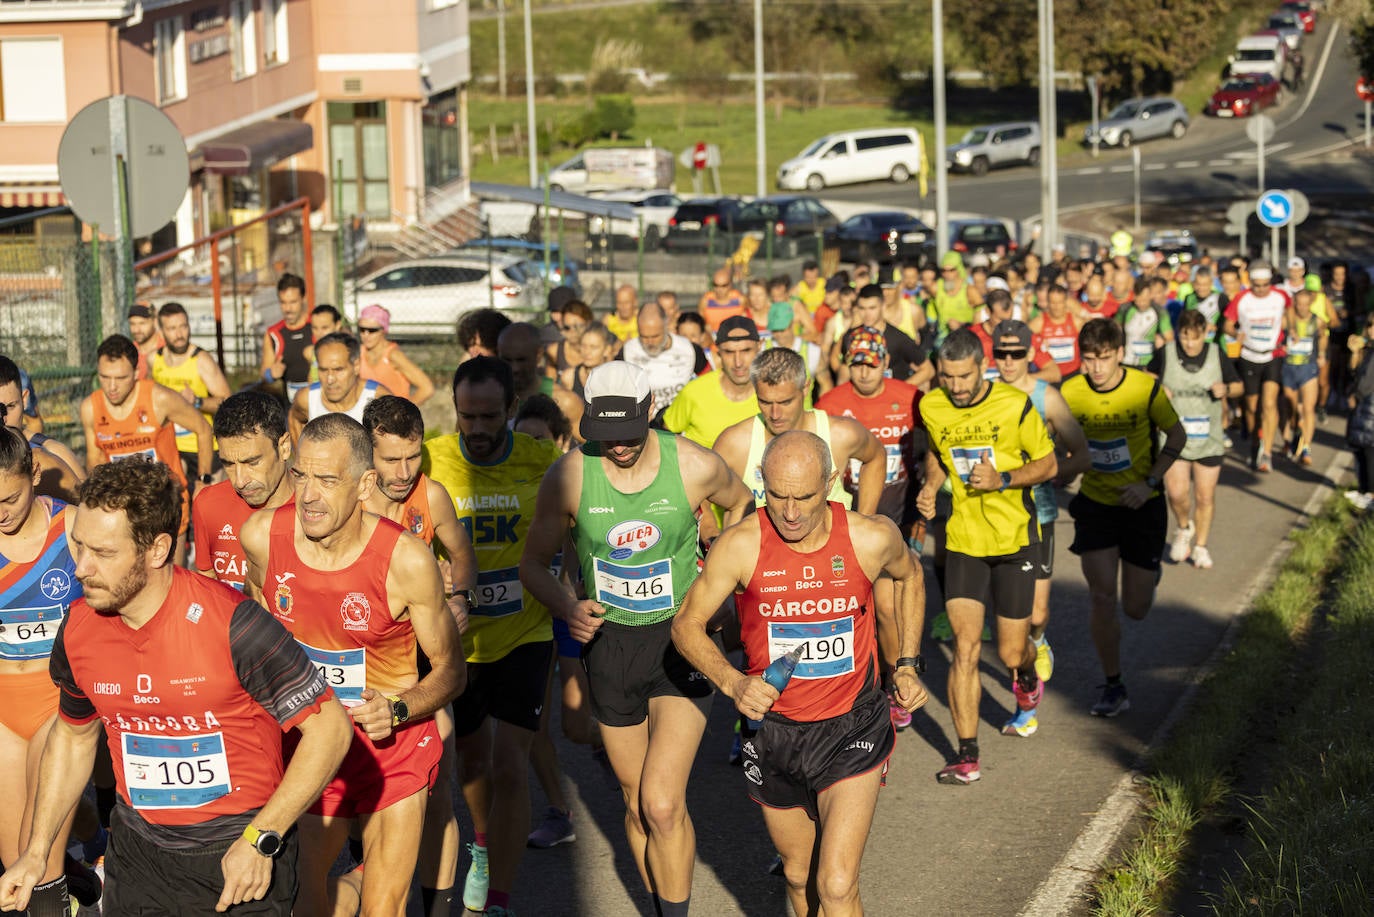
{"left": 743, "top": 689, "right": 897, "bottom": 819}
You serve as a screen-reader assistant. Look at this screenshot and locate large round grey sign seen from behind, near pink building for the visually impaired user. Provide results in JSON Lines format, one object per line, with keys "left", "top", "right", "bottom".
{"left": 58, "top": 96, "right": 191, "bottom": 236}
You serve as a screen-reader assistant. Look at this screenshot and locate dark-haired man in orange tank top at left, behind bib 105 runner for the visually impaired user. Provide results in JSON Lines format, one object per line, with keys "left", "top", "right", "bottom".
{"left": 81, "top": 334, "right": 214, "bottom": 564}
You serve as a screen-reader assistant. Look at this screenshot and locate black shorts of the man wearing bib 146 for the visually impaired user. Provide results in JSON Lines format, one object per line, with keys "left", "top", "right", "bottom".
{"left": 583, "top": 619, "right": 713, "bottom": 726}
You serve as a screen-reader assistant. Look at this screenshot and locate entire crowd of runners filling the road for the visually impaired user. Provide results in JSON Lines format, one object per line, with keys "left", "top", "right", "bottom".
{"left": 0, "top": 250, "right": 1374, "bottom": 917}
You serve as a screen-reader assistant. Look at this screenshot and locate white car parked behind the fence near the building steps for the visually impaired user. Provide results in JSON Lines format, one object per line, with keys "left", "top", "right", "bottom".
{"left": 345, "top": 252, "right": 545, "bottom": 338}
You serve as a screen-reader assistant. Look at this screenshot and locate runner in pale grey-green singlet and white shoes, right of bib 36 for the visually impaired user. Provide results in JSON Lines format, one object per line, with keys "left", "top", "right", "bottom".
{"left": 1149, "top": 309, "right": 1247, "bottom": 569}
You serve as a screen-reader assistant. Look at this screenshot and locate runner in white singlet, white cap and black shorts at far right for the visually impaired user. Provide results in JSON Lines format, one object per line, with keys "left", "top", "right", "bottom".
{"left": 1226, "top": 261, "right": 1290, "bottom": 472}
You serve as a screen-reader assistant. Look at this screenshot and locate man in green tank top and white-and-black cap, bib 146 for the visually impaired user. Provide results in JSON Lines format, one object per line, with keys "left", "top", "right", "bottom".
{"left": 519, "top": 362, "right": 750, "bottom": 917}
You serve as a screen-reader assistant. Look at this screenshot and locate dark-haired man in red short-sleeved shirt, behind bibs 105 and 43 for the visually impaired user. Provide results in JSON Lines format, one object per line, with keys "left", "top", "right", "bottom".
{"left": 191, "top": 389, "right": 295, "bottom": 591}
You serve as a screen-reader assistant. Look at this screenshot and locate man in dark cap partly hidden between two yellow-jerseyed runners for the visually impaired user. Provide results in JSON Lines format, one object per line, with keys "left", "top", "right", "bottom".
{"left": 992, "top": 318, "right": 1088, "bottom": 692}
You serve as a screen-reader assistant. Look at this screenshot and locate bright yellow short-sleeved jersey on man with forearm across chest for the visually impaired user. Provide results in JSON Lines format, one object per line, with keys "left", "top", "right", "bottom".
{"left": 916, "top": 382, "right": 1054, "bottom": 557}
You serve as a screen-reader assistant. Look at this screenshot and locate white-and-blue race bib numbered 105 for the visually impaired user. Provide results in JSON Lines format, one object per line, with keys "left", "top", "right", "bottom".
{"left": 121, "top": 733, "right": 231, "bottom": 808}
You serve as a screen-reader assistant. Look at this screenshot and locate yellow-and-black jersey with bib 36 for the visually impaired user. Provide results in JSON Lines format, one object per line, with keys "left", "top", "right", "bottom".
{"left": 1061, "top": 366, "right": 1179, "bottom": 506}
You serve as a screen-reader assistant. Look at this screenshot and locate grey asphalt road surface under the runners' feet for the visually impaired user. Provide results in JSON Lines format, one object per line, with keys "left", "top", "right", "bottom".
{"left": 447, "top": 418, "right": 1349, "bottom": 917}
